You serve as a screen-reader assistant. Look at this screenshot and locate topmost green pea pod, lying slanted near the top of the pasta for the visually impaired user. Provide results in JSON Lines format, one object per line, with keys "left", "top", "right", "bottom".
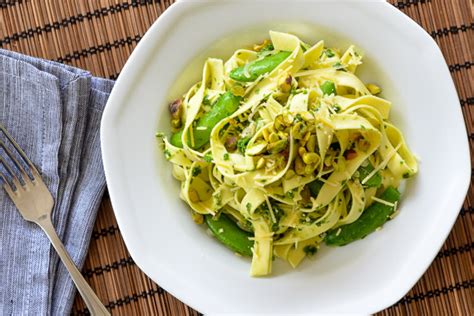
{"left": 230, "top": 52, "right": 291, "bottom": 82}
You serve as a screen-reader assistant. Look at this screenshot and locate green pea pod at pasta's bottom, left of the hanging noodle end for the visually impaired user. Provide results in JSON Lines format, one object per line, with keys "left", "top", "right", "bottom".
{"left": 204, "top": 214, "right": 253, "bottom": 257}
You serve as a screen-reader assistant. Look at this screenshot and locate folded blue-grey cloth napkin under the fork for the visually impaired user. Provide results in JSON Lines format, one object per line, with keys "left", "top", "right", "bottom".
{"left": 0, "top": 49, "right": 113, "bottom": 315}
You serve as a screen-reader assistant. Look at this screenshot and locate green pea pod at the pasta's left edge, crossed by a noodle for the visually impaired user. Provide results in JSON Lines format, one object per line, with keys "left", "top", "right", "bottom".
{"left": 170, "top": 92, "right": 241, "bottom": 149}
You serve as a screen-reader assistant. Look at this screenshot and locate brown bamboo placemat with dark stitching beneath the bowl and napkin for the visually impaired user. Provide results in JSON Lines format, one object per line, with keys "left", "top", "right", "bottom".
{"left": 0, "top": 0, "right": 474, "bottom": 315}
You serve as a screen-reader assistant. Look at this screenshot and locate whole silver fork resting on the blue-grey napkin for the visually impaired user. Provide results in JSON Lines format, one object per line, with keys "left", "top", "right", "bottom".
{"left": 0, "top": 124, "right": 110, "bottom": 315}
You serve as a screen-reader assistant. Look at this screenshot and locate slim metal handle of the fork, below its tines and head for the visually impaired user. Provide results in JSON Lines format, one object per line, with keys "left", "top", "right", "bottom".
{"left": 37, "top": 216, "right": 110, "bottom": 316}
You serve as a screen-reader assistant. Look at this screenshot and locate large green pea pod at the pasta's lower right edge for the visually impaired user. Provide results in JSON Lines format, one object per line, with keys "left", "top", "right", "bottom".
{"left": 324, "top": 187, "right": 400, "bottom": 246}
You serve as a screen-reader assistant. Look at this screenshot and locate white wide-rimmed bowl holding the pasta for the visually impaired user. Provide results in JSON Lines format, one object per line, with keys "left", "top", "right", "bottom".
{"left": 101, "top": 0, "right": 470, "bottom": 314}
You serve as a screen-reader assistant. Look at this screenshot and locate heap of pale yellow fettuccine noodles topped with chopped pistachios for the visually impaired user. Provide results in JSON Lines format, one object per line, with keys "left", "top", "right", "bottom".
{"left": 159, "top": 31, "right": 418, "bottom": 276}
